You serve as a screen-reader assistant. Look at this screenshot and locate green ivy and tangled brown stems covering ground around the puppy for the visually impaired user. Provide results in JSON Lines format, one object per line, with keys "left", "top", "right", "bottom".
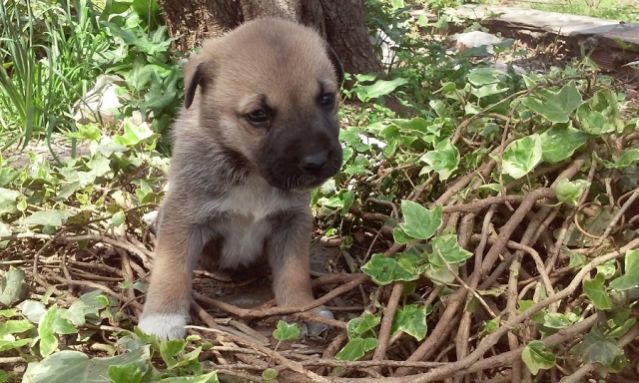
{"left": 0, "top": 1, "right": 639, "bottom": 382}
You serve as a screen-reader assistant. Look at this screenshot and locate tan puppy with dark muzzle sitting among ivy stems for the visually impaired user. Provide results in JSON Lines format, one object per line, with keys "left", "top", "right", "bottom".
{"left": 139, "top": 18, "right": 343, "bottom": 339}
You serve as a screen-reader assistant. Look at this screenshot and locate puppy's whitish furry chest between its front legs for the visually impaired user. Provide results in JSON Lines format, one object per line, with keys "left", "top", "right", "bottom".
{"left": 211, "top": 183, "right": 295, "bottom": 268}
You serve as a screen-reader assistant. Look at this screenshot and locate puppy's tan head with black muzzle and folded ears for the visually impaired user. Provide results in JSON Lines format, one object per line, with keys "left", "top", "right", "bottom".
{"left": 185, "top": 18, "right": 343, "bottom": 190}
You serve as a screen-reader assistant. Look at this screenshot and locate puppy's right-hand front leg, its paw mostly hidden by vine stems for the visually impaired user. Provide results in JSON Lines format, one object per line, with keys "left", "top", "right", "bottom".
{"left": 267, "top": 210, "right": 333, "bottom": 335}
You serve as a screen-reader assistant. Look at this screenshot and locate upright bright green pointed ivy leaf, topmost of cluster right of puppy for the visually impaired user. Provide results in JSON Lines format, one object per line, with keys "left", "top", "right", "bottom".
{"left": 399, "top": 200, "right": 442, "bottom": 239}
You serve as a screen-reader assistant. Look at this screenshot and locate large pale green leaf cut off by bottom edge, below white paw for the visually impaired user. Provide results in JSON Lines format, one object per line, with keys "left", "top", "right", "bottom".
{"left": 23, "top": 346, "right": 150, "bottom": 383}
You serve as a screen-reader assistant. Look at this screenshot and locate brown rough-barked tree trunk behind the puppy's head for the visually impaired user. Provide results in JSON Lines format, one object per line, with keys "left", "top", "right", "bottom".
{"left": 160, "top": 0, "right": 381, "bottom": 73}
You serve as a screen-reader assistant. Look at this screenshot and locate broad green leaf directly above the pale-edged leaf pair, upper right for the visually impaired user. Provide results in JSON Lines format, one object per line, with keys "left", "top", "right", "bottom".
{"left": 522, "top": 81, "right": 583, "bottom": 123}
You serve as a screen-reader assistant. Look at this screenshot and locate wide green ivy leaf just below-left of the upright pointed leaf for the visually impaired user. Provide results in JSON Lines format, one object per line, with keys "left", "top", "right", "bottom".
{"left": 362, "top": 254, "right": 420, "bottom": 286}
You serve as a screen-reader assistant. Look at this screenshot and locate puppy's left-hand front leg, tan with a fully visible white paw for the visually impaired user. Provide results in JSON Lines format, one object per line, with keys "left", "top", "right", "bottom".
{"left": 139, "top": 207, "right": 206, "bottom": 339}
